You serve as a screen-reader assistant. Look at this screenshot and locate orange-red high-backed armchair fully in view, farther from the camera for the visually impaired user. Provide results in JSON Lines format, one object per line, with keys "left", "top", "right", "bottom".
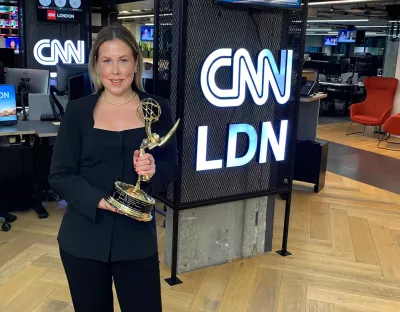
{"left": 346, "top": 77, "right": 397, "bottom": 135}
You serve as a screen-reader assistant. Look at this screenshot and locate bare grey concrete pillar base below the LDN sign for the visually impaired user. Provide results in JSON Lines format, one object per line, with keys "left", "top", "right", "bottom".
{"left": 164, "top": 196, "right": 275, "bottom": 273}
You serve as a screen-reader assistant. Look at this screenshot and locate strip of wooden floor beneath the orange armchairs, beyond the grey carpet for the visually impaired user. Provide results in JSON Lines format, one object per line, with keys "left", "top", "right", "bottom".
{"left": 317, "top": 122, "right": 400, "bottom": 159}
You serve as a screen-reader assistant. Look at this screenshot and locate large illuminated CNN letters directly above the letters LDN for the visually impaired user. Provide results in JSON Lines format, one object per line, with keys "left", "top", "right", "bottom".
{"left": 200, "top": 49, "right": 293, "bottom": 107}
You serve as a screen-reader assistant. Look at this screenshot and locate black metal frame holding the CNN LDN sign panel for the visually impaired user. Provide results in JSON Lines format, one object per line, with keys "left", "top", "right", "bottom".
{"left": 154, "top": 0, "right": 308, "bottom": 286}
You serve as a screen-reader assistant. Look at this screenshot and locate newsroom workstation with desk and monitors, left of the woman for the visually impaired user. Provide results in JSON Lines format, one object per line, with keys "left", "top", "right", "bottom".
{"left": 0, "top": 64, "right": 92, "bottom": 230}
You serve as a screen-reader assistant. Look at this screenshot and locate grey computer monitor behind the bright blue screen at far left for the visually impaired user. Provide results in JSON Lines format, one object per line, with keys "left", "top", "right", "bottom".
{"left": 6, "top": 68, "right": 50, "bottom": 93}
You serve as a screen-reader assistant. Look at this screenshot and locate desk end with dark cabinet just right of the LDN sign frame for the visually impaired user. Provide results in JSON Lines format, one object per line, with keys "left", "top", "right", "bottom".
{"left": 293, "top": 93, "right": 328, "bottom": 193}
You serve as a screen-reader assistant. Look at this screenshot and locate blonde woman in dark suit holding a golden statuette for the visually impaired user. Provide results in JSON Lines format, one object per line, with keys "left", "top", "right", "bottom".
{"left": 49, "top": 26, "right": 178, "bottom": 312}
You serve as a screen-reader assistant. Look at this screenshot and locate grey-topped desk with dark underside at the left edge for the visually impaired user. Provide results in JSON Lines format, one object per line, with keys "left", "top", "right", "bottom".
{"left": 0, "top": 121, "right": 58, "bottom": 218}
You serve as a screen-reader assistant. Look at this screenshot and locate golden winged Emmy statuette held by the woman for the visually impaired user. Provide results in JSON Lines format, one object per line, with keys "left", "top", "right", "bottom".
{"left": 106, "top": 98, "right": 179, "bottom": 222}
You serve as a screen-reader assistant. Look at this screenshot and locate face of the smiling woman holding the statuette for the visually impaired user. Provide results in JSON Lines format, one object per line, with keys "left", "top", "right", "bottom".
{"left": 97, "top": 39, "right": 138, "bottom": 96}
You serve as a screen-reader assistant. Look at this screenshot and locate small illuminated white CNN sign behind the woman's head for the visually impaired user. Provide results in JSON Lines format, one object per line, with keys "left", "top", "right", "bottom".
{"left": 33, "top": 39, "right": 85, "bottom": 66}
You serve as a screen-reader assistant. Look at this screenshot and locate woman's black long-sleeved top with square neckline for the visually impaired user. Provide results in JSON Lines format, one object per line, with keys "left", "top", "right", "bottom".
{"left": 49, "top": 92, "right": 179, "bottom": 262}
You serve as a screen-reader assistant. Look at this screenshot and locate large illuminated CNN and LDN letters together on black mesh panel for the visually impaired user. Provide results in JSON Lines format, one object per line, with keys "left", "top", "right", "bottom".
{"left": 196, "top": 49, "right": 293, "bottom": 171}
